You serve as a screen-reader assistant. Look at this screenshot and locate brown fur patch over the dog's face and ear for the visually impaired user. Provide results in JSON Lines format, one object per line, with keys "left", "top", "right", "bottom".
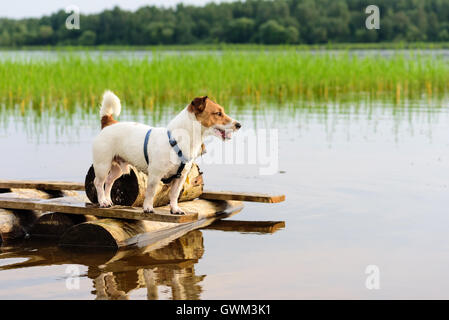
{"left": 188, "top": 96, "right": 232, "bottom": 128}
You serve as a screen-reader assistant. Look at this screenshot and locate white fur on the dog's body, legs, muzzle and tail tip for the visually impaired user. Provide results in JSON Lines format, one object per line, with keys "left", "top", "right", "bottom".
{"left": 92, "top": 91, "right": 236, "bottom": 214}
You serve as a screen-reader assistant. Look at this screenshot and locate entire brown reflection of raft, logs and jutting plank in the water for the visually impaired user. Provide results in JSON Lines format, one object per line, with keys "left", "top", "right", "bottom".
{"left": 0, "top": 220, "right": 285, "bottom": 300}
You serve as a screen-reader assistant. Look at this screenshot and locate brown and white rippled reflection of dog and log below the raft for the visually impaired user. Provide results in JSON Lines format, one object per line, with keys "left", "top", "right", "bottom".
{"left": 88, "top": 231, "right": 206, "bottom": 300}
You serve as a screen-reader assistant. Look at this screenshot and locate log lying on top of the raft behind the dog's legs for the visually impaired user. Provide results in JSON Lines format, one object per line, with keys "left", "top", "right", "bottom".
{"left": 85, "top": 164, "right": 203, "bottom": 207}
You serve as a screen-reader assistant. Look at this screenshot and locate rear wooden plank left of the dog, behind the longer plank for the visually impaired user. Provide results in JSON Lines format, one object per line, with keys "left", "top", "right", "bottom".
{"left": 0, "top": 180, "right": 84, "bottom": 191}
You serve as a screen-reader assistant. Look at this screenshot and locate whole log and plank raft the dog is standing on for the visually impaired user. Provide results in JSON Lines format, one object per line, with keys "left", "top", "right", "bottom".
{"left": 0, "top": 176, "right": 285, "bottom": 249}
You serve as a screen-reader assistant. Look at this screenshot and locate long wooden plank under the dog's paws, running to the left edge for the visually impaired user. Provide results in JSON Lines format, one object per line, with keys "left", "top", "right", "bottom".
{"left": 0, "top": 197, "right": 198, "bottom": 223}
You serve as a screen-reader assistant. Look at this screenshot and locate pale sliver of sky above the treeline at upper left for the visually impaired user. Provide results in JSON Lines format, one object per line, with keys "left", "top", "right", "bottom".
{"left": 0, "top": 0, "right": 228, "bottom": 19}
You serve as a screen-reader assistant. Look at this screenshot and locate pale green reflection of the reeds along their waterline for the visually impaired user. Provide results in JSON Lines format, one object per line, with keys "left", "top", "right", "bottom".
{"left": 0, "top": 99, "right": 448, "bottom": 144}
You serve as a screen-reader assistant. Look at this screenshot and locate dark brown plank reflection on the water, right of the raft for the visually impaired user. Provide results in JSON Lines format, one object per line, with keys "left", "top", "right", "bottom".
{"left": 205, "top": 220, "right": 285, "bottom": 233}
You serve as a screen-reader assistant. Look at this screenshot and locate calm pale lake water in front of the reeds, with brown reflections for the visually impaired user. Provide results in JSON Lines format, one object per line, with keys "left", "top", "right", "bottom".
{"left": 0, "top": 95, "right": 449, "bottom": 299}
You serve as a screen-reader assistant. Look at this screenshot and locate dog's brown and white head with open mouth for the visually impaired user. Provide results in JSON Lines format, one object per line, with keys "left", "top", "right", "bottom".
{"left": 188, "top": 96, "right": 242, "bottom": 141}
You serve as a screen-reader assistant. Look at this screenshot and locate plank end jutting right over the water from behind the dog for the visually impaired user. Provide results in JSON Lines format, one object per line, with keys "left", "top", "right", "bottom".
{"left": 200, "top": 190, "right": 285, "bottom": 203}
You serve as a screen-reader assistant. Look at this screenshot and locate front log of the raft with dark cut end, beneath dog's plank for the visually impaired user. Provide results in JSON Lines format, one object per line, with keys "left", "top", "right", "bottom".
{"left": 59, "top": 199, "right": 243, "bottom": 250}
